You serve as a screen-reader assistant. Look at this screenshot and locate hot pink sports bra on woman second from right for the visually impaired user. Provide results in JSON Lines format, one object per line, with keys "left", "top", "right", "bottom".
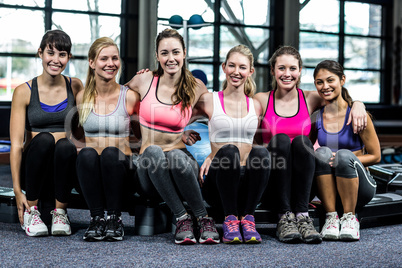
{"left": 261, "top": 88, "right": 311, "bottom": 144}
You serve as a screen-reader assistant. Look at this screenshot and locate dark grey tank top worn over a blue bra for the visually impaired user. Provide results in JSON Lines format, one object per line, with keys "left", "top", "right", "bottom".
{"left": 25, "top": 76, "right": 75, "bottom": 132}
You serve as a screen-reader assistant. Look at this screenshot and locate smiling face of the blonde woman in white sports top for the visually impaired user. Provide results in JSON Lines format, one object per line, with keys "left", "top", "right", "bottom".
{"left": 222, "top": 52, "right": 254, "bottom": 88}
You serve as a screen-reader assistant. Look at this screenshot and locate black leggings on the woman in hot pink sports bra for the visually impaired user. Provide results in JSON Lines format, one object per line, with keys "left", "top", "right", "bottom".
{"left": 263, "top": 133, "right": 315, "bottom": 214}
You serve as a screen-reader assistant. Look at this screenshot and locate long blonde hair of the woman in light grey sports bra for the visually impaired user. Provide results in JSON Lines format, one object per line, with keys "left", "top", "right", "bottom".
{"left": 78, "top": 37, "right": 120, "bottom": 125}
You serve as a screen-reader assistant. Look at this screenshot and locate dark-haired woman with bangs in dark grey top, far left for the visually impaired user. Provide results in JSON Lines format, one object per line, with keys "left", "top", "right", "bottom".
{"left": 10, "top": 30, "right": 83, "bottom": 236}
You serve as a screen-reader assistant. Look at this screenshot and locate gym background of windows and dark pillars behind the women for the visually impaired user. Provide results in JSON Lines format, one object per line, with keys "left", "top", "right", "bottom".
{"left": 0, "top": 0, "right": 402, "bottom": 140}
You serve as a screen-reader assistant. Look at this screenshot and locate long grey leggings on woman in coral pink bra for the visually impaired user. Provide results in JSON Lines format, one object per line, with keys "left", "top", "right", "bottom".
{"left": 137, "top": 145, "right": 207, "bottom": 218}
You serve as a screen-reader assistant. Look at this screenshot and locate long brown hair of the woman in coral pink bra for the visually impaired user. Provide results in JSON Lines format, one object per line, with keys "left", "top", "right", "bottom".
{"left": 152, "top": 29, "right": 197, "bottom": 111}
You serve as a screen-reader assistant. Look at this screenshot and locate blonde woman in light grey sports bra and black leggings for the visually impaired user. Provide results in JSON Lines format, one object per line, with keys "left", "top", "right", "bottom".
{"left": 77, "top": 37, "right": 139, "bottom": 241}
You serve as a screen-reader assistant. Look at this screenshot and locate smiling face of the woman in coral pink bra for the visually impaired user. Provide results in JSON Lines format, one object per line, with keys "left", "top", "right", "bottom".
{"left": 156, "top": 37, "right": 186, "bottom": 75}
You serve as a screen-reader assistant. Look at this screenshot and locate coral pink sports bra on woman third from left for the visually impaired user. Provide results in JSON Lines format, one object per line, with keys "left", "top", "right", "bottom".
{"left": 139, "top": 76, "right": 192, "bottom": 133}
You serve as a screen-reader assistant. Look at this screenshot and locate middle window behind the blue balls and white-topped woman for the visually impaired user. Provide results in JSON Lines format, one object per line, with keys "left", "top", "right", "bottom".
{"left": 158, "top": 0, "right": 273, "bottom": 91}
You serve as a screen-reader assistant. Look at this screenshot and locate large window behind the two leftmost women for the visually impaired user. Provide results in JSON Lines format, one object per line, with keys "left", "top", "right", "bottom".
{"left": 0, "top": 0, "right": 124, "bottom": 101}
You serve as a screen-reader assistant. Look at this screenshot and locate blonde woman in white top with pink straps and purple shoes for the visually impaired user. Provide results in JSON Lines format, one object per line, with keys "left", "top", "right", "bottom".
{"left": 197, "top": 45, "right": 270, "bottom": 243}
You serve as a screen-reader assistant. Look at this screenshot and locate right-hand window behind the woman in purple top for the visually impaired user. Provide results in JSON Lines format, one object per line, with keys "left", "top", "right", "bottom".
{"left": 299, "top": 0, "right": 392, "bottom": 103}
